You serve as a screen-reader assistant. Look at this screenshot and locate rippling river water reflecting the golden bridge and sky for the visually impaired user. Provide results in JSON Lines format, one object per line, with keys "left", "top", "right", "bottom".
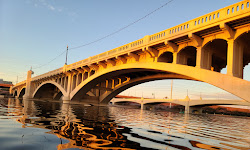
{"left": 0, "top": 99, "right": 250, "bottom": 150}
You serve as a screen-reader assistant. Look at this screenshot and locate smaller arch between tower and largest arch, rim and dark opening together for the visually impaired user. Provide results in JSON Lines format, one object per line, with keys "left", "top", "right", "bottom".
{"left": 32, "top": 81, "right": 67, "bottom": 100}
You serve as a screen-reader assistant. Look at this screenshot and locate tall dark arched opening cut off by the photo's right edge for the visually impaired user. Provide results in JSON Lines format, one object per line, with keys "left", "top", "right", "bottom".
{"left": 234, "top": 32, "right": 250, "bottom": 81}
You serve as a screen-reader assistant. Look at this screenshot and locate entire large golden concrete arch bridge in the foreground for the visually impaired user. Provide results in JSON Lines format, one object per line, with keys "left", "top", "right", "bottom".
{"left": 10, "top": 0, "right": 250, "bottom": 108}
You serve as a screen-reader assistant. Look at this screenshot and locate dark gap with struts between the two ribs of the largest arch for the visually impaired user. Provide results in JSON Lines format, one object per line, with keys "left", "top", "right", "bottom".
{"left": 71, "top": 69, "right": 182, "bottom": 101}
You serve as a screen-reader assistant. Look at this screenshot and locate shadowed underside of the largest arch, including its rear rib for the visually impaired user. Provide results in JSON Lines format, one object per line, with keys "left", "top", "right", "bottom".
{"left": 69, "top": 68, "right": 194, "bottom": 104}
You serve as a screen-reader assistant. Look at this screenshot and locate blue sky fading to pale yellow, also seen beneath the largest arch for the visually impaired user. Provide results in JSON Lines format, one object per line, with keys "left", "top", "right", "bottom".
{"left": 0, "top": 0, "right": 250, "bottom": 99}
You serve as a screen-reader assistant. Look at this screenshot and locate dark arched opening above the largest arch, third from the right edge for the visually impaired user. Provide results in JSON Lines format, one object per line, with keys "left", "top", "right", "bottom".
{"left": 177, "top": 46, "right": 197, "bottom": 67}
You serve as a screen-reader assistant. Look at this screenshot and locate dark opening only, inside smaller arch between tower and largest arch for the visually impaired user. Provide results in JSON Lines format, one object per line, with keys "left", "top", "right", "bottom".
{"left": 34, "top": 83, "right": 63, "bottom": 100}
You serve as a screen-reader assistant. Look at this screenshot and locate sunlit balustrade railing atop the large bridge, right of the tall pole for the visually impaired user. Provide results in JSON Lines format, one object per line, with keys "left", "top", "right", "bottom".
{"left": 67, "top": 0, "right": 249, "bottom": 70}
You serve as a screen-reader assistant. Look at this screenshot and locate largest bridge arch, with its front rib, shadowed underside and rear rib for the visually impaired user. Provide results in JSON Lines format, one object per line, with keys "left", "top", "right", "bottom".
{"left": 67, "top": 63, "right": 250, "bottom": 104}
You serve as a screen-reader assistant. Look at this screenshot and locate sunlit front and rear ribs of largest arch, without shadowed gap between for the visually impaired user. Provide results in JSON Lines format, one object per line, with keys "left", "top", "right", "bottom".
{"left": 70, "top": 62, "right": 250, "bottom": 103}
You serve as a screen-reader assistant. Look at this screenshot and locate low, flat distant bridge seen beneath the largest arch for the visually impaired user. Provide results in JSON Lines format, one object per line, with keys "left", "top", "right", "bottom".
{"left": 110, "top": 96, "right": 250, "bottom": 113}
